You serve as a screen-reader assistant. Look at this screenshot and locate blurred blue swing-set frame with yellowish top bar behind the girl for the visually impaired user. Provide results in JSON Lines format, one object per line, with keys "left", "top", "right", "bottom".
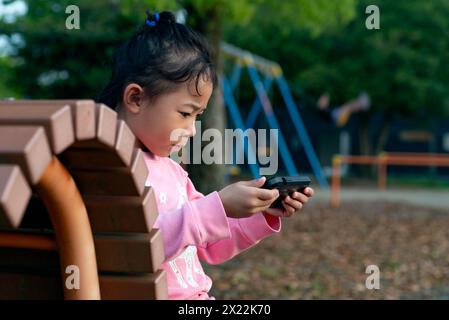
{"left": 220, "top": 43, "right": 328, "bottom": 189}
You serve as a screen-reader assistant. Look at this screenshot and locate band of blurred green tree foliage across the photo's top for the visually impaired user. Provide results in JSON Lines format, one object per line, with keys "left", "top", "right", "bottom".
{"left": 0, "top": 0, "right": 449, "bottom": 121}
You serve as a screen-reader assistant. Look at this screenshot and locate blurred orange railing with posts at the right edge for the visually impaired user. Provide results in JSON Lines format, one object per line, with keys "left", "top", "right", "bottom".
{"left": 330, "top": 152, "right": 449, "bottom": 208}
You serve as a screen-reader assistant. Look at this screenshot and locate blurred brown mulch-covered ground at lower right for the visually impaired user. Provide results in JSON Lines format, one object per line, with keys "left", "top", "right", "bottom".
{"left": 205, "top": 202, "right": 449, "bottom": 299}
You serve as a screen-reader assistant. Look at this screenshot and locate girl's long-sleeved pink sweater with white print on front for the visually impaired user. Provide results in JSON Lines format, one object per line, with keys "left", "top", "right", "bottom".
{"left": 144, "top": 153, "right": 281, "bottom": 299}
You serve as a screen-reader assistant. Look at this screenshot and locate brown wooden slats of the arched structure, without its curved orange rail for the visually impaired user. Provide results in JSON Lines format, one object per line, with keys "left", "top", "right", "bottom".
{"left": 0, "top": 100, "right": 168, "bottom": 299}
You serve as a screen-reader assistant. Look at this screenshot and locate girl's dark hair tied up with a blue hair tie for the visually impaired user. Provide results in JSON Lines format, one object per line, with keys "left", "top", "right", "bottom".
{"left": 98, "top": 11, "right": 217, "bottom": 109}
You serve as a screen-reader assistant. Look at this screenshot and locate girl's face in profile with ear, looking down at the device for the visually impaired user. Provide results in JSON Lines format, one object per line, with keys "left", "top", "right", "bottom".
{"left": 119, "top": 78, "right": 213, "bottom": 157}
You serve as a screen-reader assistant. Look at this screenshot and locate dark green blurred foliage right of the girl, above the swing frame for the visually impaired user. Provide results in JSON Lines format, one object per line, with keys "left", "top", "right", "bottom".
{"left": 225, "top": 0, "right": 449, "bottom": 117}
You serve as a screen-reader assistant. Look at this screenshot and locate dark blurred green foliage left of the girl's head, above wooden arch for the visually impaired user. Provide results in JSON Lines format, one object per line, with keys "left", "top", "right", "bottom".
{"left": 0, "top": 0, "right": 176, "bottom": 99}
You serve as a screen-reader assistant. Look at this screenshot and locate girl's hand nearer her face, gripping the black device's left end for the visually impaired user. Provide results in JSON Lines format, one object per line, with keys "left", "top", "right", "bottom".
{"left": 218, "top": 177, "right": 279, "bottom": 218}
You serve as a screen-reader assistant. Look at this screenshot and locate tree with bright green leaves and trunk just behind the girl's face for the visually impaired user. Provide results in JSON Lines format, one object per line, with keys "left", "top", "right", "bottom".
{"left": 180, "top": 0, "right": 355, "bottom": 191}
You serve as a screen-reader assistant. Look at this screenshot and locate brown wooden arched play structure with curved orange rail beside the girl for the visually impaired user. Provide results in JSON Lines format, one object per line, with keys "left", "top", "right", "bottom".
{"left": 0, "top": 100, "right": 168, "bottom": 299}
